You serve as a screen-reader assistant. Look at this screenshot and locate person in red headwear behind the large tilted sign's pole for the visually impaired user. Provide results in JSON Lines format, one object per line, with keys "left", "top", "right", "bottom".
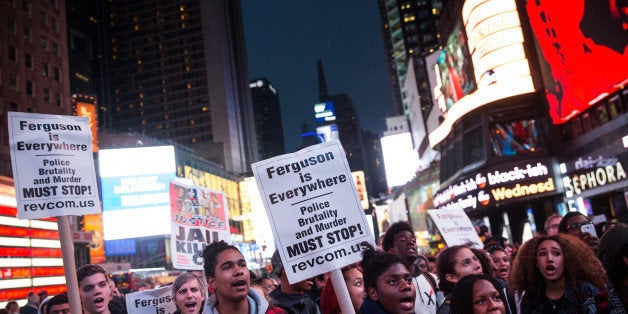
{"left": 320, "top": 265, "right": 366, "bottom": 314}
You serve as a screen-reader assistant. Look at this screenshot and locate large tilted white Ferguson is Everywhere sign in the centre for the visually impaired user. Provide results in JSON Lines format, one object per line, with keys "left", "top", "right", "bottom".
{"left": 252, "top": 141, "right": 373, "bottom": 283}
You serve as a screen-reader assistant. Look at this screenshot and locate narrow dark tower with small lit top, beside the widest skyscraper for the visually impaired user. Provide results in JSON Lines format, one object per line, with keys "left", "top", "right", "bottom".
{"left": 250, "top": 78, "right": 286, "bottom": 159}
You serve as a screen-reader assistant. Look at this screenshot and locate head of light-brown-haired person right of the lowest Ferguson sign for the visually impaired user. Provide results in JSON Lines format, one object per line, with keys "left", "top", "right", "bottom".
{"left": 172, "top": 273, "right": 206, "bottom": 314}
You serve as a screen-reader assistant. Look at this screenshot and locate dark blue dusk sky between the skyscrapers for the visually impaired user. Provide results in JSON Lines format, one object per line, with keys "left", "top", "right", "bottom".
{"left": 242, "top": 0, "right": 392, "bottom": 153}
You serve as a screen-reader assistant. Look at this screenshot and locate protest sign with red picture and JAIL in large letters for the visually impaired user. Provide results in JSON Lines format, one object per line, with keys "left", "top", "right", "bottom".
{"left": 170, "top": 181, "right": 231, "bottom": 270}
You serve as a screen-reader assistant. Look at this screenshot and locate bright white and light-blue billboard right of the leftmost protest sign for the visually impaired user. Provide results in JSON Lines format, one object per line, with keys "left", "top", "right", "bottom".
{"left": 98, "top": 146, "right": 176, "bottom": 240}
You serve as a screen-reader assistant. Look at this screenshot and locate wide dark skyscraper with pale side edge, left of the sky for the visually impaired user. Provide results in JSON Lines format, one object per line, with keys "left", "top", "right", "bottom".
{"left": 108, "top": 0, "right": 258, "bottom": 173}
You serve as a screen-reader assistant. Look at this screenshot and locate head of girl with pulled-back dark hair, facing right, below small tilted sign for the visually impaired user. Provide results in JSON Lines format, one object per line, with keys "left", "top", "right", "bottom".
{"left": 436, "top": 245, "right": 482, "bottom": 314}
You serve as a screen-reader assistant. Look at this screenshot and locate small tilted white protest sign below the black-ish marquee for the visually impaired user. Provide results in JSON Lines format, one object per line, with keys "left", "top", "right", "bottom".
{"left": 427, "top": 208, "right": 484, "bottom": 249}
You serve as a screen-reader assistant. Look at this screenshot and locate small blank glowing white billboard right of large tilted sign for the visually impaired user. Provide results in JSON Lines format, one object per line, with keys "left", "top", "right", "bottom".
{"left": 381, "top": 132, "right": 420, "bottom": 188}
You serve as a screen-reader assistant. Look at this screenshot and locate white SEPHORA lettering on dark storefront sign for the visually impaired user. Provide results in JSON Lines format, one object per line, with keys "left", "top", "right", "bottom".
{"left": 563, "top": 162, "right": 626, "bottom": 197}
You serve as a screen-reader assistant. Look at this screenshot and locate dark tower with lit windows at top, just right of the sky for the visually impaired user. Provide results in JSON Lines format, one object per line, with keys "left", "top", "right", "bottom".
{"left": 379, "top": 0, "right": 443, "bottom": 116}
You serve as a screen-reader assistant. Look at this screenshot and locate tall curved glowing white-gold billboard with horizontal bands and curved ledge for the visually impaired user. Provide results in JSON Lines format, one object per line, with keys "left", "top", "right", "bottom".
{"left": 429, "top": 0, "right": 535, "bottom": 147}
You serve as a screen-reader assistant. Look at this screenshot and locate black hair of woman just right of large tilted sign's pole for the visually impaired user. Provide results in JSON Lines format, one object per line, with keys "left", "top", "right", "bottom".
{"left": 361, "top": 242, "right": 405, "bottom": 291}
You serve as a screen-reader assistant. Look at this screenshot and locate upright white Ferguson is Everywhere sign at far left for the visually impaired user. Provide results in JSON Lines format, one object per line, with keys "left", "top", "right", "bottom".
{"left": 8, "top": 112, "right": 100, "bottom": 219}
